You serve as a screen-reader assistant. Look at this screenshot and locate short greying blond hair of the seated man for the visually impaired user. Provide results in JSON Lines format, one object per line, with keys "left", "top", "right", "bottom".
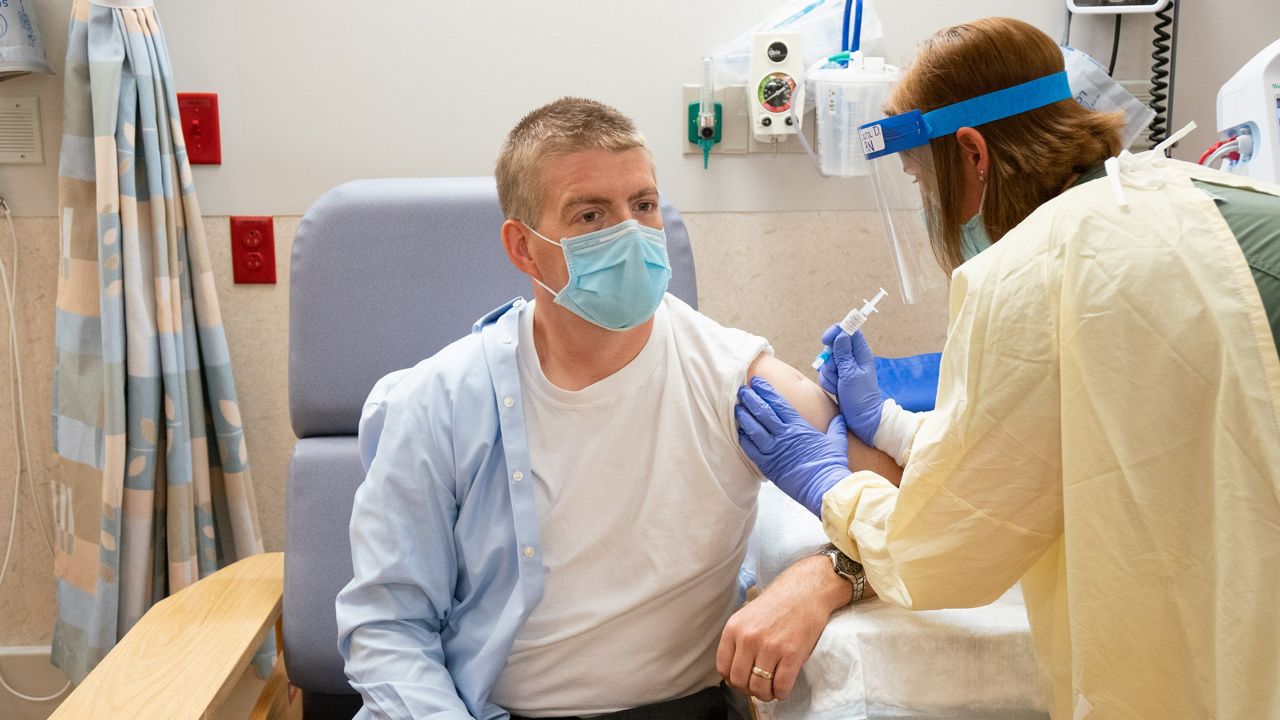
{"left": 494, "top": 97, "right": 653, "bottom": 223}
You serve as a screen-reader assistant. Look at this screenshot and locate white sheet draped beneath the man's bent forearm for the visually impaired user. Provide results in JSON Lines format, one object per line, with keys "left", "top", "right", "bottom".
{"left": 753, "top": 483, "right": 1048, "bottom": 720}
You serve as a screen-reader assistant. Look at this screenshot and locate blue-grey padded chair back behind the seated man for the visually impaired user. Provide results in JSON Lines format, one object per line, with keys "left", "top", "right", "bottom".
{"left": 284, "top": 178, "right": 698, "bottom": 720}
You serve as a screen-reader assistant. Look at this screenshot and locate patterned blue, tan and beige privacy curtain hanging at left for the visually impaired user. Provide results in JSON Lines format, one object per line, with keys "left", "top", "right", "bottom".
{"left": 52, "top": 0, "right": 271, "bottom": 682}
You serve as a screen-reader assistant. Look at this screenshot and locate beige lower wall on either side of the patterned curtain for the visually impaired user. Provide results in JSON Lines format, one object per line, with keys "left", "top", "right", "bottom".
{"left": 0, "top": 218, "right": 297, "bottom": 646}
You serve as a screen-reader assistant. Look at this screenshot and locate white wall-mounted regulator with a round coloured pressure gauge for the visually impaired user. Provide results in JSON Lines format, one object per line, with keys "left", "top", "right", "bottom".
{"left": 746, "top": 32, "right": 804, "bottom": 146}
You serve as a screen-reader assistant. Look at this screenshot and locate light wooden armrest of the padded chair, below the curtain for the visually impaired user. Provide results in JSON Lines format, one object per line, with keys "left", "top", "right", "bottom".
{"left": 50, "top": 552, "right": 284, "bottom": 720}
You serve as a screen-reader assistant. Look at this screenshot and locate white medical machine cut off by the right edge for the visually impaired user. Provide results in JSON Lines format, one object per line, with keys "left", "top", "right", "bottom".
{"left": 1217, "top": 40, "right": 1280, "bottom": 182}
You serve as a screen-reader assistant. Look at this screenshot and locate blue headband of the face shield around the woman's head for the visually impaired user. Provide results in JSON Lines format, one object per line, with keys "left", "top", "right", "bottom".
{"left": 858, "top": 70, "right": 1073, "bottom": 160}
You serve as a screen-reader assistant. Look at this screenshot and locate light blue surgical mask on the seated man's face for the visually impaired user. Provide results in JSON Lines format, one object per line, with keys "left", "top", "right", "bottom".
{"left": 526, "top": 220, "right": 671, "bottom": 331}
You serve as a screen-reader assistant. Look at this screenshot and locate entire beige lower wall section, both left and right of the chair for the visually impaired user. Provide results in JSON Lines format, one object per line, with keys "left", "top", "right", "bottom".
{"left": 0, "top": 206, "right": 946, "bottom": 646}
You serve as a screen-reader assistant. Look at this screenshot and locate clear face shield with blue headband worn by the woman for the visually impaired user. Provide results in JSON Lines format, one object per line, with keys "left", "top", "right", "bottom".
{"left": 858, "top": 73, "right": 1071, "bottom": 302}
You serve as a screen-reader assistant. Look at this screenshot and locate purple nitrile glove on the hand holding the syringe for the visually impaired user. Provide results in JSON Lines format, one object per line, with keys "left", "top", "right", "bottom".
{"left": 818, "top": 325, "right": 884, "bottom": 447}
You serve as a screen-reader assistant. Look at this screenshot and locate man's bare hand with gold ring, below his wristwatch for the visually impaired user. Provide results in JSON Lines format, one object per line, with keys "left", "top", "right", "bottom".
{"left": 716, "top": 555, "right": 854, "bottom": 702}
